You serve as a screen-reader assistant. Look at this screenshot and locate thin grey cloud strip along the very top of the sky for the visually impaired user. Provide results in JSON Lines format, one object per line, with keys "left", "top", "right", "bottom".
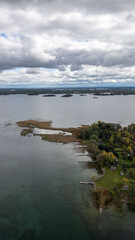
{"left": 0, "top": 0, "right": 135, "bottom": 14}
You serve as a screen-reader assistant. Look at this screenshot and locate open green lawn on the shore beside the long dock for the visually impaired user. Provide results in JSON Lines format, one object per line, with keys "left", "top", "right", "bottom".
{"left": 96, "top": 167, "right": 123, "bottom": 190}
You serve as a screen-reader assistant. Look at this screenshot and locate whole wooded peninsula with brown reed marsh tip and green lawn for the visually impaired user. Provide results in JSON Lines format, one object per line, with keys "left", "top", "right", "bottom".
{"left": 17, "top": 120, "right": 135, "bottom": 209}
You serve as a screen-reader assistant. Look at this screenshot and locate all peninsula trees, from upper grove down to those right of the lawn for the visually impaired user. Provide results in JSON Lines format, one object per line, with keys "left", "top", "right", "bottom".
{"left": 78, "top": 121, "right": 135, "bottom": 203}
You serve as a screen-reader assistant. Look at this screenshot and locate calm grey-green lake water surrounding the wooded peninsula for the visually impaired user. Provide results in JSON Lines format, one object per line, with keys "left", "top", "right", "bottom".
{"left": 0, "top": 95, "right": 135, "bottom": 240}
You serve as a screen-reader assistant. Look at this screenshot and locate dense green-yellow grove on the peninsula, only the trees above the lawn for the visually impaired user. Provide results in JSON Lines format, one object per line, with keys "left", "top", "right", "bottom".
{"left": 78, "top": 121, "right": 135, "bottom": 166}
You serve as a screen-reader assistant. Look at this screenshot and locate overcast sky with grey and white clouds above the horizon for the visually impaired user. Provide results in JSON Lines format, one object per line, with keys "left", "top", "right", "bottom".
{"left": 0, "top": 0, "right": 135, "bottom": 87}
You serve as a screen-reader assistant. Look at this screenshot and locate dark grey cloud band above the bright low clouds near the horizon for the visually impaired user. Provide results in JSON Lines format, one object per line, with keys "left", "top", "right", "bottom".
{"left": 0, "top": 45, "right": 135, "bottom": 72}
